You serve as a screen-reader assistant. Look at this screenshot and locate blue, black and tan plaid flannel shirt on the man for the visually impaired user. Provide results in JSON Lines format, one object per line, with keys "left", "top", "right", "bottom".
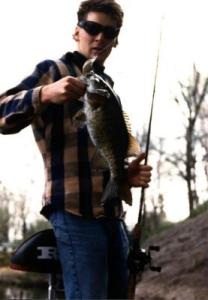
{"left": 0, "top": 52, "right": 122, "bottom": 217}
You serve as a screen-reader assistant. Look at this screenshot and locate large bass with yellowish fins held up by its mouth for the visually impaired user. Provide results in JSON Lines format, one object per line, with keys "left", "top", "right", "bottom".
{"left": 78, "top": 59, "right": 141, "bottom": 207}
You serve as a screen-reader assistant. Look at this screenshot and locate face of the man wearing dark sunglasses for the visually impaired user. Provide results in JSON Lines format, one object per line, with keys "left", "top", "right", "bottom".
{"left": 74, "top": 12, "right": 117, "bottom": 64}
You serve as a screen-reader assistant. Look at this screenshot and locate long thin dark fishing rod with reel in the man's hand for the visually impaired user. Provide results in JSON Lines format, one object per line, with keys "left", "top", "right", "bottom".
{"left": 128, "top": 17, "right": 163, "bottom": 299}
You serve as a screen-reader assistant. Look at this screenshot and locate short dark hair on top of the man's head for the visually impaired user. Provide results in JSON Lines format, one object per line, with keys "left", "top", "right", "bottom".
{"left": 77, "top": 0, "right": 124, "bottom": 28}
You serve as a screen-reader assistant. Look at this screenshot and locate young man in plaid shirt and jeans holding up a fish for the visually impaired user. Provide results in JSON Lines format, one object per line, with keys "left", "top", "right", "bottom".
{"left": 0, "top": 0, "right": 151, "bottom": 299}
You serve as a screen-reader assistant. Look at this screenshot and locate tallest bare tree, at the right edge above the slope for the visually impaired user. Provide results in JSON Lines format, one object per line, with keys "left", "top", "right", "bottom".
{"left": 171, "top": 66, "right": 208, "bottom": 214}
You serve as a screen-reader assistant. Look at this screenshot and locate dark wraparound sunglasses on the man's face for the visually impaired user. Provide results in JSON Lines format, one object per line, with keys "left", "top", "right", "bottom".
{"left": 78, "top": 20, "right": 120, "bottom": 39}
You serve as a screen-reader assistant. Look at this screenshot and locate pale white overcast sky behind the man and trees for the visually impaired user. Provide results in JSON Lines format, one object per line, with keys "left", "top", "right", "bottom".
{"left": 0, "top": 0, "right": 208, "bottom": 223}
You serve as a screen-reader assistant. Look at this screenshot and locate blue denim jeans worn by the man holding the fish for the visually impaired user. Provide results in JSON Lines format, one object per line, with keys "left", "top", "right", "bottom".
{"left": 49, "top": 211, "right": 129, "bottom": 300}
